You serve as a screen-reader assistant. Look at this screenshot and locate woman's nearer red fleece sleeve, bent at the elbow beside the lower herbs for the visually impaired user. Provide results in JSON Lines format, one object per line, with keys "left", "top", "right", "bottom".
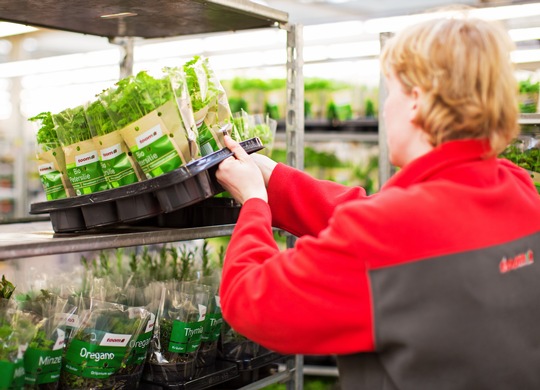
{"left": 220, "top": 199, "right": 374, "bottom": 354}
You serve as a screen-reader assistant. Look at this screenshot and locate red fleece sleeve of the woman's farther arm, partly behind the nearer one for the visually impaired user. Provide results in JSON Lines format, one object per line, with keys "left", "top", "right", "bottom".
{"left": 268, "top": 164, "right": 366, "bottom": 237}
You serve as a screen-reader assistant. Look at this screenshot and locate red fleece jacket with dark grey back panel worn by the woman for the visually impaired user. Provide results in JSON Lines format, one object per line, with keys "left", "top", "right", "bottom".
{"left": 220, "top": 140, "right": 540, "bottom": 389}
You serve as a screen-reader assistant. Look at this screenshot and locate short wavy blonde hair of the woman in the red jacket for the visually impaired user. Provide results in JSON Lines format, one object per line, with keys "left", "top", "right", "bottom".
{"left": 381, "top": 14, "right": 519, "bottom": 155}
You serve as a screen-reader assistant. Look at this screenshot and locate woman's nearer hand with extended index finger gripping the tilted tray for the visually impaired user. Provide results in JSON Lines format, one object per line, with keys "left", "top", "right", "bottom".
{"left": 216, "top": 135, "right": 271, "bottom": 204}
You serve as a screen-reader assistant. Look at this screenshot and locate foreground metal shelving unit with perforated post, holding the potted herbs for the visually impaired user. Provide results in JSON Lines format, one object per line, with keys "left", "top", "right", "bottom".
{"left": 0, "top": 0, "right": 304, "bottom": 389}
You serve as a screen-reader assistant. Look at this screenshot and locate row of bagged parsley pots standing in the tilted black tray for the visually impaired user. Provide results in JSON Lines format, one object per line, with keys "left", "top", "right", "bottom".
{"left": 29, "top": 56, "right": 273, "bottom": 200}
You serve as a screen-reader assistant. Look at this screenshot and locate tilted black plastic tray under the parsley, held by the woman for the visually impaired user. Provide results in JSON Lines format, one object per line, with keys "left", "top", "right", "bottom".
{"left": 30, "top": 138, "right": 264, "bottom": 233}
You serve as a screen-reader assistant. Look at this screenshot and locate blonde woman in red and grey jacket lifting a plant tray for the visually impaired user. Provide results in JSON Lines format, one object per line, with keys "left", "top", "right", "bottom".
{"left": 217, "top": 12, "right": 540, "bottom": 390}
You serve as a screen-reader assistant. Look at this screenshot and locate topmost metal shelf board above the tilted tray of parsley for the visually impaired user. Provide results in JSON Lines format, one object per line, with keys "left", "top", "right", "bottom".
{"left": 0, "top": 0, "right": 288, "bottom": 38}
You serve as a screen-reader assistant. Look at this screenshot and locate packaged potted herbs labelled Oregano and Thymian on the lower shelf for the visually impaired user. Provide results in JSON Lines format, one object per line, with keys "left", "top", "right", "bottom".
{"left": 0, "top": 241, "right": 270, "bottom": 390}
